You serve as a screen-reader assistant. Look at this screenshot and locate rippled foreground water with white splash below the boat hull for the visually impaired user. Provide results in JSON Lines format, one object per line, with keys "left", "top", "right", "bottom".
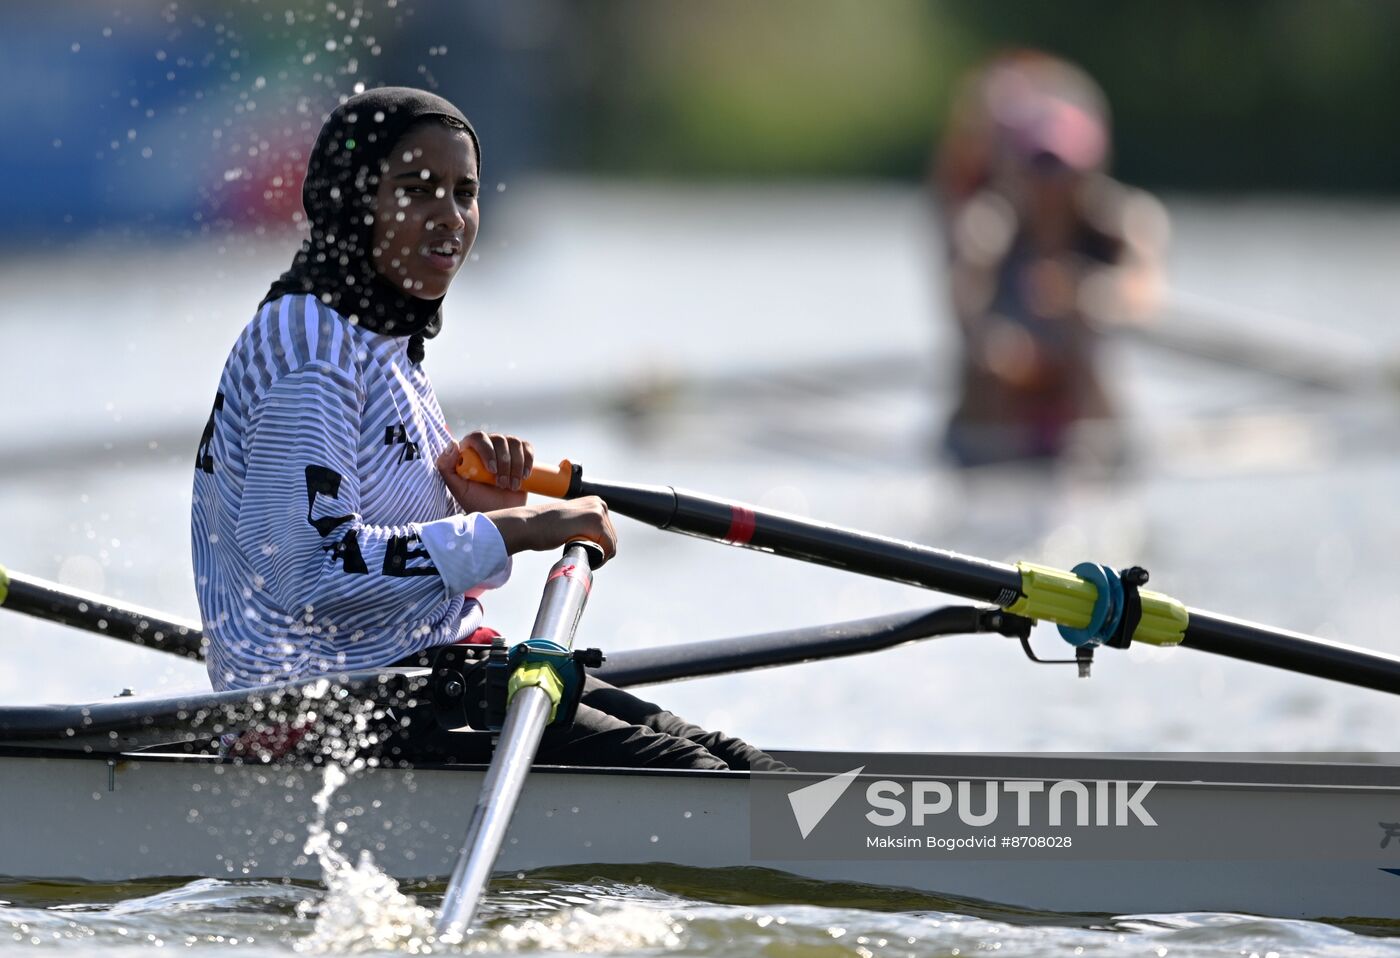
{"left": 8, "top": 866, "right": 1400, "bottom": 958}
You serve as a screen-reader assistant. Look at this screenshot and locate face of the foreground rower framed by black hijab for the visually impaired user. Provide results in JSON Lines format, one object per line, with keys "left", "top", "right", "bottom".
{"left": 372, "top": 122, "right": 480, "bottom": 300}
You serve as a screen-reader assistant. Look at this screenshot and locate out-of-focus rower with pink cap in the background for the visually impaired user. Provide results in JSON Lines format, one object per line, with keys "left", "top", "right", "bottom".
{"left": 932, "top": 50, "right": 1168, "bottom": 466}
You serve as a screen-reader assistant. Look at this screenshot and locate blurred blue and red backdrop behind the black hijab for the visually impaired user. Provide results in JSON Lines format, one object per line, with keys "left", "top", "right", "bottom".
{"left": 0, "top": 0, "right": 556, "bottom": 245}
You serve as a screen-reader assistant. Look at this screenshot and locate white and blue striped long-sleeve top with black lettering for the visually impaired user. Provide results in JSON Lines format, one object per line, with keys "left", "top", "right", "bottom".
{"left": 190, "top": 296, "right": 511, "bottom": 689}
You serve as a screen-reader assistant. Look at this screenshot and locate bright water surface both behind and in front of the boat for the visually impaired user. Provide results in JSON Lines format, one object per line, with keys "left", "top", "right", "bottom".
{"left": 0, "top": 183, "right": 1400, "bottom": 957}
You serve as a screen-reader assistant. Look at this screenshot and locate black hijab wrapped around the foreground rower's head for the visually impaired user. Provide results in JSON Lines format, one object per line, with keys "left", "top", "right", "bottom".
{"left": 259, "top": 87, "right": 482, "bottom": 363}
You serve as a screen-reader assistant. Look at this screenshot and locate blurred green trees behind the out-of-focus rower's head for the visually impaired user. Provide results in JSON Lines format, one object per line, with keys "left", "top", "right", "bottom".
{"left": 570, "top": 0, "right": 1400, "bottom": 192}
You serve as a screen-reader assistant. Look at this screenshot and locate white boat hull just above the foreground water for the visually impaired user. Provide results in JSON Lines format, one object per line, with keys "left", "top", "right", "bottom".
{"left": 8, "top": 754, "right": 1400, "bottom": 919}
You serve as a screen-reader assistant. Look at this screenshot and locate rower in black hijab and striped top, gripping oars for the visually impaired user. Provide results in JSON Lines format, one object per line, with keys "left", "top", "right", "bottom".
{"left": 192, "top": 87, "right": 783, "bottom": 769}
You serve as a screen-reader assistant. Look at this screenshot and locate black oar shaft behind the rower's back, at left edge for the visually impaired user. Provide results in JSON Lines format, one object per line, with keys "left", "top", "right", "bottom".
{"left": 0, "top": 566, "right": 204, "bottom": 660}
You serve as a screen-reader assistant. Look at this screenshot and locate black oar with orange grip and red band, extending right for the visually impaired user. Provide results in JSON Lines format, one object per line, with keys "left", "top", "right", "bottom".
{"left": 458, "top": 450, "right": 1400, "bottom": 693}
